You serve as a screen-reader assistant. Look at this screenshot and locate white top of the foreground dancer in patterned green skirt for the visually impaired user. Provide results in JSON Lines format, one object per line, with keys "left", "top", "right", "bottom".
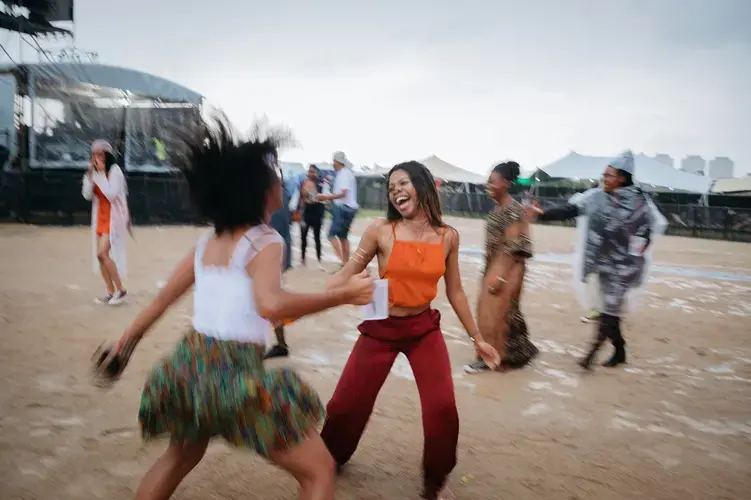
{"left": 193, "top": 224, "right": 284, "bottom": 345}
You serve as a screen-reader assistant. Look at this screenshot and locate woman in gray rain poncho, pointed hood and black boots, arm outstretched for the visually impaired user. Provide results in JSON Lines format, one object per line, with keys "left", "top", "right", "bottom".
{"left": 530, "top": 151, "right": 664, "bottom": 369}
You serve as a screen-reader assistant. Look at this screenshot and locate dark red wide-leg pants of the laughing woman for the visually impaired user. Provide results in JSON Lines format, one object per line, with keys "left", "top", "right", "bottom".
{"left": 321, "top": 309, "right": 459, "bottom": 490}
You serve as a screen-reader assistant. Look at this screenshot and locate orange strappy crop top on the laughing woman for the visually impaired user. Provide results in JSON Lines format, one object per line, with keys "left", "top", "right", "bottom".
{"left": 381, "top": 223, "right": 446, "bottom": 307}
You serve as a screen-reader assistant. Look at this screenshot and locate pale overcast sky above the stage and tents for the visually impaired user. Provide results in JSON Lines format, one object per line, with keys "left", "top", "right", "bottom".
{"left": 7, "top": 0, "right": 751, "bottom": 173}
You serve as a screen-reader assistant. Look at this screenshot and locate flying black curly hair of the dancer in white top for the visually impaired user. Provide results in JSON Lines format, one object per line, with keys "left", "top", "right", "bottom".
{"left": 174, "top": 113, "right": 289, "bottom": 234}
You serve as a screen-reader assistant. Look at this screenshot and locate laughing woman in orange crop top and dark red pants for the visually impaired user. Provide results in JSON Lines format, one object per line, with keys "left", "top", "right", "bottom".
{"left": 321, "top": 161, "right": 500, "bottom": 500}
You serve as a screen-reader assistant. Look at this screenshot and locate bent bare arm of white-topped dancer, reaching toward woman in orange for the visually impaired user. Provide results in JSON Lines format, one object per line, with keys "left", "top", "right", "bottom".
{"left": 247, "top": 243, "right": 353, "bottom": 323}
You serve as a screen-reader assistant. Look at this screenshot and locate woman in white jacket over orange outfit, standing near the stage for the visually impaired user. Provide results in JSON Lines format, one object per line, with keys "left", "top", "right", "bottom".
{"left": 82, "top": 139, "right": 130, "bottom": 305}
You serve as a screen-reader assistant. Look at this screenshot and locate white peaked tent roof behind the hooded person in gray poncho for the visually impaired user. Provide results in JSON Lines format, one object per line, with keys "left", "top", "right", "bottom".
{"left": 539, "top": 151, "right": 712, "bottom": 194}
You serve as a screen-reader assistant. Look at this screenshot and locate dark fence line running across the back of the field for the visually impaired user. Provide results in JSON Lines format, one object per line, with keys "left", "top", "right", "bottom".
{"left": 0, "top": 171, "right": 751, "bottom": 242}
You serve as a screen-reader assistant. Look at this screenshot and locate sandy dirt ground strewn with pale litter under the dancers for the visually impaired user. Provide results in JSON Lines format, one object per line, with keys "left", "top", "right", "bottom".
{"left": 0, "top": 219, "right": 751, "bottom": 500}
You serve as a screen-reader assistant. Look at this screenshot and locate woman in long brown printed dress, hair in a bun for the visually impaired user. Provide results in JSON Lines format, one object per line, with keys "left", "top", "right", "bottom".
{"left": 464, "top": 162, "right": 539, "bottom": 373}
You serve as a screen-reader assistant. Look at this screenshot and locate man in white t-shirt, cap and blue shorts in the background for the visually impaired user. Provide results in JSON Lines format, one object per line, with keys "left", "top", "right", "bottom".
{"left": 316, "top": 151, "right": 360, "bottom": 265}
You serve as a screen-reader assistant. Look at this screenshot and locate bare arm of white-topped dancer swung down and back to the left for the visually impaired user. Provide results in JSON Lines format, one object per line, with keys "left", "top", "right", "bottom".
{"left": 123, "top": 249, "right": 196, "bottom": 340}
